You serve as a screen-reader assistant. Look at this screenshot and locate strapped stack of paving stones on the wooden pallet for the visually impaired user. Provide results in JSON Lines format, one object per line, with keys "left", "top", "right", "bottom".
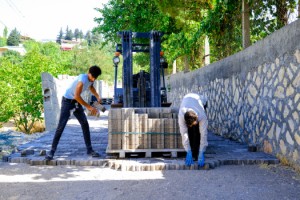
{"left": 108, "top": 107, "right": 183, "bottom": 153}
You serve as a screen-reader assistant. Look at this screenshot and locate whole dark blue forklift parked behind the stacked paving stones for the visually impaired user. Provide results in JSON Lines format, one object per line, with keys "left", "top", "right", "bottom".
{"left": 111, "top": 31, "right": 171, "bottom": 108}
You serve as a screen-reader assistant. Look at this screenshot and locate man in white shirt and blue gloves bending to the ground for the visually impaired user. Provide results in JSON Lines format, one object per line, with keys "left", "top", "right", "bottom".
{"left": 178, "top": 93, "right": 208, "bottom": 167}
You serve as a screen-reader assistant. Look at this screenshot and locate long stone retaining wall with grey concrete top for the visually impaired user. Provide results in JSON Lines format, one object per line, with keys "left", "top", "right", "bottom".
{"left": 166, "top": 20, "right": 300, "bottom": 166}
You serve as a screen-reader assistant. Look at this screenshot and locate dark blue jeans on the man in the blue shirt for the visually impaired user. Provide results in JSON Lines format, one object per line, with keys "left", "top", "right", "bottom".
{"left": 51, "top": 97, "right": 93, "bottom": 153}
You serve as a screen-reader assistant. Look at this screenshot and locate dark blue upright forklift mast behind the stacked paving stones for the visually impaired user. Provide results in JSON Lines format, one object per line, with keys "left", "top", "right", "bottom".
{"left": 114, "top": 31, "right": 165, "bottom": 108}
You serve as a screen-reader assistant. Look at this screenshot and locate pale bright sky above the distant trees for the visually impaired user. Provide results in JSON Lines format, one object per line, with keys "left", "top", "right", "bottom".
{"left": 0, "top": 0, "right": 108, "bottom": 41}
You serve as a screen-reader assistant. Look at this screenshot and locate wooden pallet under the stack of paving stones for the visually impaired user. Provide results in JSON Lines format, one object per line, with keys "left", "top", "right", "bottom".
{"left": 106, "top": 149, "right": 185, "bottom": 158}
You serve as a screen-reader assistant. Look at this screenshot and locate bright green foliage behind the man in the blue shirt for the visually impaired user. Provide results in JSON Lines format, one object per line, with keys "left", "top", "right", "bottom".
{"left": 0, "top": 37, "right": 115, "bottom": 133}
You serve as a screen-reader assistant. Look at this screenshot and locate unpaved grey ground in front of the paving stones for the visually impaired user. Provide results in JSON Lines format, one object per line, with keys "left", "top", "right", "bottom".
{"left": 0, "top": 162, "right": 300, "bottom": 200}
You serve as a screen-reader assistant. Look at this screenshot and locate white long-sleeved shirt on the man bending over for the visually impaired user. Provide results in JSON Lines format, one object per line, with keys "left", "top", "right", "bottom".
{"left": 178, "top": 93, "right": 208, "bottom": 152}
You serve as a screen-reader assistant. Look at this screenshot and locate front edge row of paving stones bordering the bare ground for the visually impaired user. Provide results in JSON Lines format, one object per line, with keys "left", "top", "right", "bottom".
{"left": 2, "top": 156, "right": 279, "bottom": 171}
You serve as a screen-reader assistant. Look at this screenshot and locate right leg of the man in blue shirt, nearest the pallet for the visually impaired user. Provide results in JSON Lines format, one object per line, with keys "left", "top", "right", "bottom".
{"left": 74, "top": 104, "right": 100, "bottom": 157}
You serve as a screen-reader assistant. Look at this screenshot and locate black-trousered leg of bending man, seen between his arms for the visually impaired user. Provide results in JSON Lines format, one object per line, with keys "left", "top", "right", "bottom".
{"left": 188, "top": 123, "right": 200, "bottom": 160}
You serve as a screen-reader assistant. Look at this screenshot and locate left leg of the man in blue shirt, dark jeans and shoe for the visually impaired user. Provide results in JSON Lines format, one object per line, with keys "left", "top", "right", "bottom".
{"left": 46, "top": 99, "right": 74, "bottom": 160}
